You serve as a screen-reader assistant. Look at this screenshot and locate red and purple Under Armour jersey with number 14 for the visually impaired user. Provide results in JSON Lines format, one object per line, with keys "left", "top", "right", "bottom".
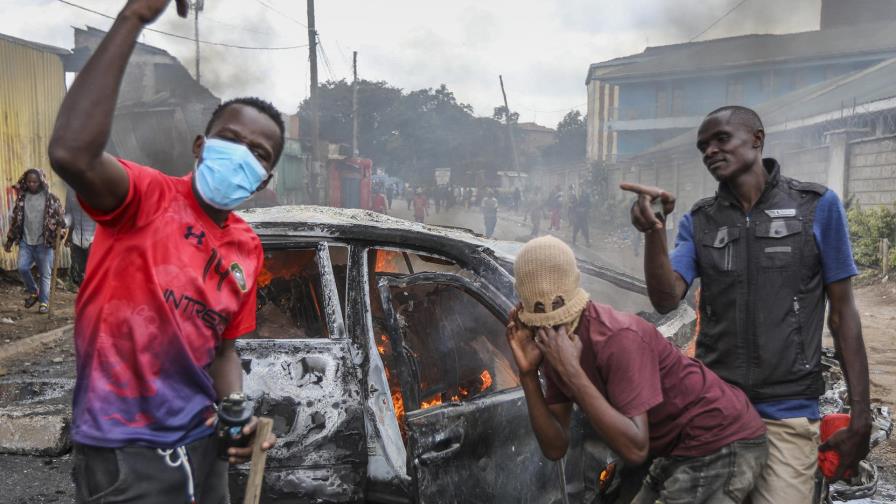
{"left": 72, "top": 160, "right": 263, "bottom": 447}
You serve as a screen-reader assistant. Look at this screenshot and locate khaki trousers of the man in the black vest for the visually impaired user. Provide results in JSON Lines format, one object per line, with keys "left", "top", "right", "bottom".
{"left": 750, "top": 418, "right": 820, "bottom": 504}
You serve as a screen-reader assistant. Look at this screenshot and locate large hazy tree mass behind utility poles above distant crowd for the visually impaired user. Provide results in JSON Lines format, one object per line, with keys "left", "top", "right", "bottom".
{"left": 299, "top": 80, "right": 510, "bottom": 183}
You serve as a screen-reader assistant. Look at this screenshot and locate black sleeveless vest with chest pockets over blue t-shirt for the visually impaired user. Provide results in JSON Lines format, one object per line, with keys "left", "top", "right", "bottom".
{"left": 691, "top": 158, "right": 827, "bottom": 402}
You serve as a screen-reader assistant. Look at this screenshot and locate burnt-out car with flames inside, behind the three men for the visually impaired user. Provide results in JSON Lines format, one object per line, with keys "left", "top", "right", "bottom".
{"left": 231, "top": 207, "right": 694, "bottom": 503}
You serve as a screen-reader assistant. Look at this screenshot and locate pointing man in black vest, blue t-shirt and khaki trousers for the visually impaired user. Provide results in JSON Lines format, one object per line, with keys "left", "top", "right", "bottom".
{"left": 621, "top": 106, "right": 871, "bottom": 504}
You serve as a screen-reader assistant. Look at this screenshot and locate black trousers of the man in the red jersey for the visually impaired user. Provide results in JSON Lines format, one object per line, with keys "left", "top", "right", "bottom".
{"left": 72, "top": 436, "right": 230, "bottom": 504}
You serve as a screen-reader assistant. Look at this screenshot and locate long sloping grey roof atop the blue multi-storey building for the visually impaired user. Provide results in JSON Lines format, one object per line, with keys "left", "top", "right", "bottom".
{"left": 586, "top": 23, "right": 896, "bottom": 82}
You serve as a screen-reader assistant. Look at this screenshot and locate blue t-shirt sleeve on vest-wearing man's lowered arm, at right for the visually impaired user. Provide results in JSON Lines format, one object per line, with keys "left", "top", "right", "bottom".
{"left": 812, "top": 190, "right": 859, "bottom": 285}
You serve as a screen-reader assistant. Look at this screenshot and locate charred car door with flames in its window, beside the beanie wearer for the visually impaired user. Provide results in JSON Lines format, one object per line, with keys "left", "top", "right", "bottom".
{"left": 378, "top": 273, "right": 561, "bottom": 503}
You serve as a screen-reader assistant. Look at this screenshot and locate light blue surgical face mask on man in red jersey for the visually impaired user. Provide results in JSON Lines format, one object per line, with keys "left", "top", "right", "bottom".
{"left": 194, "top": 138, "right": 268, "bottom": 210}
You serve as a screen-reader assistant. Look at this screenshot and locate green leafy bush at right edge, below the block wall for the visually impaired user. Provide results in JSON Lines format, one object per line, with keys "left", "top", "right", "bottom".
{"left": 846, "top": 206, "right": 896, "bottom": 269}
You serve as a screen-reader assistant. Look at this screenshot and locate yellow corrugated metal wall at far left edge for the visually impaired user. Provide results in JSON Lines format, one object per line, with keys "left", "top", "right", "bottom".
{"left": 0, "top": 39, "right": 68, "bottom": 269}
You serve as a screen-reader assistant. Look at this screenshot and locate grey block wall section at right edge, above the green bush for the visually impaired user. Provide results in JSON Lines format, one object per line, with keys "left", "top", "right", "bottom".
{"left": 847, "top": 136, "right": 896, "bottom": 207}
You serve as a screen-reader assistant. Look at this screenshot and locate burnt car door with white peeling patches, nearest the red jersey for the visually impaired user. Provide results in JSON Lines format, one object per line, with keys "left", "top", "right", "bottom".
{"left": 231, "top": 243, "right": 367, "bottom": 503}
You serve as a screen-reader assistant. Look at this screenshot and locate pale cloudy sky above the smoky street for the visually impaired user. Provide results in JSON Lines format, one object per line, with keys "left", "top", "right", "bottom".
{"left": 0, "top": 0, "right": 820, "bottom": 126}
